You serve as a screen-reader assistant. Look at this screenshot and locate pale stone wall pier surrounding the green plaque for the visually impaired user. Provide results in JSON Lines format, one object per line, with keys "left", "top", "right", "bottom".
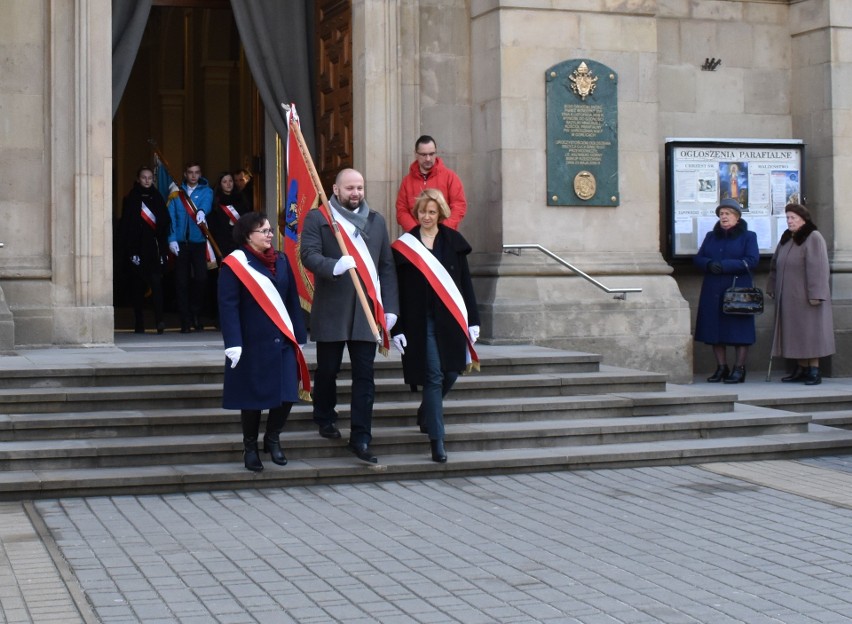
{"left": 464, "top": 0, "right": 692, "bottom": 382}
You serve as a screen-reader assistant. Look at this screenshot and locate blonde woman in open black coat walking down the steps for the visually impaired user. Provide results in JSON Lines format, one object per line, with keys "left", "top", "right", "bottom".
{"left": 392, "top": 189, "right": 479, "bottom": 463}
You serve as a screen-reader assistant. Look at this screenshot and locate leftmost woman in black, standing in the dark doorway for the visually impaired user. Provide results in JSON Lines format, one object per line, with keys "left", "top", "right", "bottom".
{"left": 118, "top": 167, "right": 171, "bottom": 334}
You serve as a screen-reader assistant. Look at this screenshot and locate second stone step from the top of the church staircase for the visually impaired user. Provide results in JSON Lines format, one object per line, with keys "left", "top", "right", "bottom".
{"left": 0, "top": 367, "right": 666, "bottom": 414}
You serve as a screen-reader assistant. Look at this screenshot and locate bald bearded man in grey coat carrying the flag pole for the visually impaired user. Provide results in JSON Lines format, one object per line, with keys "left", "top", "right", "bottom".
{"left": 301, "top": 169, "right": 399, "bottom": 463}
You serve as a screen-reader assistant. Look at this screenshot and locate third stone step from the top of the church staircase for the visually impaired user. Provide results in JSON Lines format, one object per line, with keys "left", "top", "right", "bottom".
{"left": 0, "top": 387, "right": 736, "bottom": 442}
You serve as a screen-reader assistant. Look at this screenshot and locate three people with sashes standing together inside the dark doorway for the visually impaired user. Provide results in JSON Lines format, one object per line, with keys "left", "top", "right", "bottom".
{"left": 116, "top": 161, "right": 253, "bottom": 334}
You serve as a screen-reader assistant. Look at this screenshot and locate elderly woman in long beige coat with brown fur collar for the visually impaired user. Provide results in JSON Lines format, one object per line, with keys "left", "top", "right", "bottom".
{"left": 766, "top": 204, "right": 834, "bottom": 386}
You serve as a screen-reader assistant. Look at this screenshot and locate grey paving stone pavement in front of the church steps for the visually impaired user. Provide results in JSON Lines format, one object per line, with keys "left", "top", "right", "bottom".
{"left": 0, "top": 457, "right": 852, "bottom": 624}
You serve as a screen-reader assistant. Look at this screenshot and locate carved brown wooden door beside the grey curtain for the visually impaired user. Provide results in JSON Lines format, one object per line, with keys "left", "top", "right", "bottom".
{"left": 314, "top": 0, "right": 353, "bottom": 196}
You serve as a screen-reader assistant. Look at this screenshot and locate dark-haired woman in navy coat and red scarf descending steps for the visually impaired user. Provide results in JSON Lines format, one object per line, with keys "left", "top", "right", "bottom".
{"left": 219, "top": 212, "right": 307, "bottom": 472}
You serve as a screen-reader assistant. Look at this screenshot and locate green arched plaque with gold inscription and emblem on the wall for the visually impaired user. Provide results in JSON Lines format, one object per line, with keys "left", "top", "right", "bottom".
{"left": 545, "top": 59, "right": 619, "bottom": 206}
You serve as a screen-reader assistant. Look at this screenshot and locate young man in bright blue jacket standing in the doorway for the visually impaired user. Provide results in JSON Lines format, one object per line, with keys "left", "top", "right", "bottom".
{"left": 169, "top": 161, "right": 213, "bottom": 334}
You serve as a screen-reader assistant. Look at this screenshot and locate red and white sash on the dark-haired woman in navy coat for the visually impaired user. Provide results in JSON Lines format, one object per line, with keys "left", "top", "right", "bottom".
{"left": 222, "top": 249, "right": 311, "bottom": 401}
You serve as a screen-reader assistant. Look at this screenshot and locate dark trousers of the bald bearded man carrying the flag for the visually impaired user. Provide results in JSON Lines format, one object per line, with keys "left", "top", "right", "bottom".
{"left": 313, "top": 340, "right": 376, "bottom": 445}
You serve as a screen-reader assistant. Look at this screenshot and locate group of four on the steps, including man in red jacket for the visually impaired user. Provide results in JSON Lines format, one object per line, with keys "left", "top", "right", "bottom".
{"left": 213, "top": 137, "right": 479, "bottom": 472}
